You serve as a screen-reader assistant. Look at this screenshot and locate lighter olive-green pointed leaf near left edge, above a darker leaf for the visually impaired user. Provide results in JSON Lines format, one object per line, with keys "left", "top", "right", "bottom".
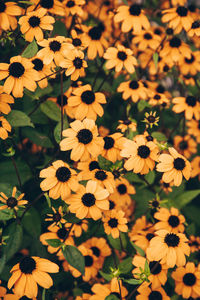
{"left": 7, "top": 110, "right": 34, "bottom": 127}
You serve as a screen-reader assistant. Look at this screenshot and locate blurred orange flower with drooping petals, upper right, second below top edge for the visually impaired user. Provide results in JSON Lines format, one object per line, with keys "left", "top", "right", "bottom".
{"left": 160, "top": 36, "right": 192, "bottom": 63}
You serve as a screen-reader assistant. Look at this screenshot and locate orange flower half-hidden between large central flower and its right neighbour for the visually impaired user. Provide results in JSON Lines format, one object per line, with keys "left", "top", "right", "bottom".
{"left": 101, "top": 132, "right": 126, "bottom": 163}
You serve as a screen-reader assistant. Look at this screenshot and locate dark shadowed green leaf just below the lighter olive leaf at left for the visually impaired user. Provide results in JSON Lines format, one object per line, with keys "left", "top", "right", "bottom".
{"left": 22, "top": 128, "right": 53, "bottom": 148}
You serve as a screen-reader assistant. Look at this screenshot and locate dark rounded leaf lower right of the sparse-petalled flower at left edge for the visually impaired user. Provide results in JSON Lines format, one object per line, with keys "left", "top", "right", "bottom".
{"left": 22, "top": 207, "right": 41, "bottom": 238}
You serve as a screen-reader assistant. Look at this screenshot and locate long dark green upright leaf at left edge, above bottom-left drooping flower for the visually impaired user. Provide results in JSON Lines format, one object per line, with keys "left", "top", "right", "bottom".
{"left": 3, "top": 222, "right": 23, "bottom": 261}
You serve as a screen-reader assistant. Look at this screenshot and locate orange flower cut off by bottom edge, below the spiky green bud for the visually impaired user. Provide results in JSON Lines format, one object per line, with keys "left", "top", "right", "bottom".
{"left": 90, "top": 277, "right": 128, "bottom": 300}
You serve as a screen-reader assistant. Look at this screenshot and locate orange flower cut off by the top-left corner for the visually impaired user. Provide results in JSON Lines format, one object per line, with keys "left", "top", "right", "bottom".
{"left": 0, "top": 1, "right": 22, "bottom": 30}
